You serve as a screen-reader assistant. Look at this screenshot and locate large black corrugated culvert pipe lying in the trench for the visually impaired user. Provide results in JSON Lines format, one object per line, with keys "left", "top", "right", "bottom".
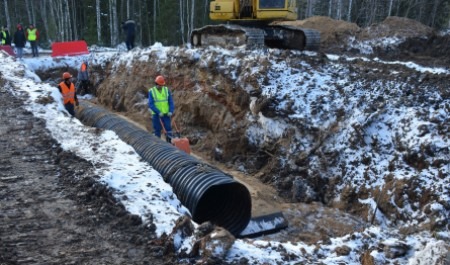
{"left": 77, "top": 101, "right": 251, "bottom": 236}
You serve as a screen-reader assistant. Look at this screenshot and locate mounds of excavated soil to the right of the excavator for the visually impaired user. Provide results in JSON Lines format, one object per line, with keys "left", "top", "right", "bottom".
{"left": 277, "top": 16, "right": 450, "bottom": 67}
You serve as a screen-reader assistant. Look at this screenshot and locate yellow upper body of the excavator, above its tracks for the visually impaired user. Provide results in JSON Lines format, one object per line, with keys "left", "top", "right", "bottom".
{"left": 209, "top": 0, "right": 297, "bottom": 23}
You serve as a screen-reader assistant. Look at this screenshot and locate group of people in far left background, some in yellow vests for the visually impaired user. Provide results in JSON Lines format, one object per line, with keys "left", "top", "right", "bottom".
{"left": 0, "top": 24, "right": 39, "bottom": 59}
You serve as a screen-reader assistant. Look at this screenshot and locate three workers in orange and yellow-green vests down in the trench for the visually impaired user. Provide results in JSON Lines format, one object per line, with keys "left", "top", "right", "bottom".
{"left": 58, "top": 68, "right": 175, "bottom": 142}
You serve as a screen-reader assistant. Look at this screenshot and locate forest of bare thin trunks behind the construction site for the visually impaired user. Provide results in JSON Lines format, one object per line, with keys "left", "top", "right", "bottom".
{"left": 0, "top": 0, "right": 450, "bottom": 48}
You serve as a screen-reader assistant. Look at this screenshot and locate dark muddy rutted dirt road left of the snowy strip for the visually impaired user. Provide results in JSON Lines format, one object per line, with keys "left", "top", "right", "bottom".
{"left": 0, "top": 87, "right": 166, "bottom": 264}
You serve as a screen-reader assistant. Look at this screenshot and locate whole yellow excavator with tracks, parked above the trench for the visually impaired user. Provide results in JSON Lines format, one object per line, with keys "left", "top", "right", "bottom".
{"left": 191, "top": 0, "right": 320, "bottom": 50}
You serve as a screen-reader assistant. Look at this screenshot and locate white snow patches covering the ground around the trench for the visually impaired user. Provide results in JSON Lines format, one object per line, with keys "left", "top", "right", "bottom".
{"left": 0, "top": 44, "right": 450, "bottom": 264}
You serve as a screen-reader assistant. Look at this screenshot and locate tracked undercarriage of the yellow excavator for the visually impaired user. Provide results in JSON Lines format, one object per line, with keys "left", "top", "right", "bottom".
{"left": 191, "top": 24, "right": 320, "bottom": 51}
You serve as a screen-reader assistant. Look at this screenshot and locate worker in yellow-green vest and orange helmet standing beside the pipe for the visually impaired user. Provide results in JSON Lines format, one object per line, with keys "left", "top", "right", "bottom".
{"left": 148, "top": 75, "right": 175, "bottom": 143}
